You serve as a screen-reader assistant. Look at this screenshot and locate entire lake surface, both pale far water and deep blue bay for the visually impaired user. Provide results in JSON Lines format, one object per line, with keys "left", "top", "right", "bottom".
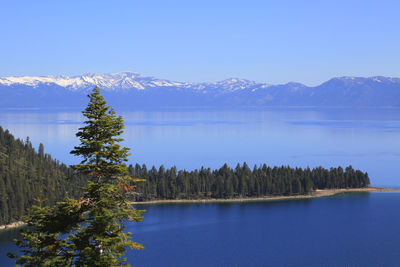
{"left": 0, "top": 109, "right": 400, "bottom": 266}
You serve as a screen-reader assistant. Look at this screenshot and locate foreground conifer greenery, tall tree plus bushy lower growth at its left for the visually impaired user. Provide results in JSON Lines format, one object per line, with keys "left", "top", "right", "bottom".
{"left": 9, "top": 87, "right": 143, "bottom": 266}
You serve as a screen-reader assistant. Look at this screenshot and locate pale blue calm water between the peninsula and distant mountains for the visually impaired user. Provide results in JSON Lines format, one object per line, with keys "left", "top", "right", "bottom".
{"left": 0, "top": 108, "right": 400, "bottom": 186}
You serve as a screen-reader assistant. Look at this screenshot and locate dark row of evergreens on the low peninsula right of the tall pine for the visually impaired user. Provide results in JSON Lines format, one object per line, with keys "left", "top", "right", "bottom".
{"left": 129, "top": 163, "right": 370, "bottom": 201}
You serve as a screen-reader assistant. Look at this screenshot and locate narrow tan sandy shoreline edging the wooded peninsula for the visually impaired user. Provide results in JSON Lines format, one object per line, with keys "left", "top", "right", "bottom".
{"left": 130, "top": 186, "right": 400, "bottom": 205}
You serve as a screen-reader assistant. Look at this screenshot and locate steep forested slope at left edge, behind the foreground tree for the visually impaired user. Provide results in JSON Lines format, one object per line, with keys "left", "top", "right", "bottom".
{"left": 0, "top": 127, "right": 83, "bottom": 225}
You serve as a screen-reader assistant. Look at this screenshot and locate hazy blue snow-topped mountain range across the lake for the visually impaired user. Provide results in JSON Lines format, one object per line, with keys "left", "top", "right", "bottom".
{"left": 0, "top": 72, "right": 400, "bottom": 108}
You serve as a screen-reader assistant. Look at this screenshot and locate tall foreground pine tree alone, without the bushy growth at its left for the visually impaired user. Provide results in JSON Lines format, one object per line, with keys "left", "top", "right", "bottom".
{"left": 71, "top": 87, "right": 142, "bottom": 266}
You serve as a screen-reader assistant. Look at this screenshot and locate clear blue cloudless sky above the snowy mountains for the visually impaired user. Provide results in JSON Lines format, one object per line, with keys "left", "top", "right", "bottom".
{"left": 0, "top": 0, "right": 400, "bottom": 85}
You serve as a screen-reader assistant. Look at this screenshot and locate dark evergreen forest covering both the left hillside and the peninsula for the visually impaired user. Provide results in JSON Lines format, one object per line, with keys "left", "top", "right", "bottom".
{"left": 0, "top": 127, "right": 370, "bottom": 225}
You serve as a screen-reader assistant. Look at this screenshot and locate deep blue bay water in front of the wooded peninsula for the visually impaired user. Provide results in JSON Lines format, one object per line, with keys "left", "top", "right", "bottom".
{"left": 0, "top": 193, "right": 400, "bottom": 267}
